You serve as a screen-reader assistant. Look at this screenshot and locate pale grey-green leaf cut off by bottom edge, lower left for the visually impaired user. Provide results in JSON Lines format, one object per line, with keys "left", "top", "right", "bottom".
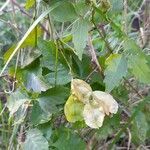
{"left": 23, "top": 128, "right": 49, "bottom": 150}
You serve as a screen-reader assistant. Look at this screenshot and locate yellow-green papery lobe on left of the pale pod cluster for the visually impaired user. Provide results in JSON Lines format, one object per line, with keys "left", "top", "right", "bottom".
{"left": 64, "top": 95, "right": 84, "bottom": 122}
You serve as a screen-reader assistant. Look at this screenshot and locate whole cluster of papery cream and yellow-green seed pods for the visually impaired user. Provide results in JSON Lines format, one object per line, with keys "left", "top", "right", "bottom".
{"left": 64, "top": 79, "right": 118, "bottom": 128}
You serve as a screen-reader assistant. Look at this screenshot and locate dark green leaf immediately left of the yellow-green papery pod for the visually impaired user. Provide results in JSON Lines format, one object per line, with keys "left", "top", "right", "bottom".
{"left": 38, "top": 86, "right": 69, "bottom": 113}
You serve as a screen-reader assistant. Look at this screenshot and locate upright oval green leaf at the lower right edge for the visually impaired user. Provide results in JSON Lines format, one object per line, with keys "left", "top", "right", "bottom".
{"left": 131, "top": 111, "right": 149, "bottom": 144}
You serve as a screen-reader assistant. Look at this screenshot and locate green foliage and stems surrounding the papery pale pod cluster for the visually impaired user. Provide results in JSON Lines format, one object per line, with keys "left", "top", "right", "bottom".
{"left": 0, "top": 0, "right": 150, "bottom": 150}
